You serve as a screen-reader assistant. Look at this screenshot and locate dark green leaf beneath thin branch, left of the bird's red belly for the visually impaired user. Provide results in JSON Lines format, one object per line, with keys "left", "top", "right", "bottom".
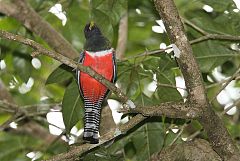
{"left": 46, "top": 64, "right": 73, "bottom": 85}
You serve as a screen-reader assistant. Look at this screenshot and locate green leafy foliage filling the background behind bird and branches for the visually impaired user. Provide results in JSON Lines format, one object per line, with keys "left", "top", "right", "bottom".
{"left": 0, "top": 0, "right": 240, "bottom": 161}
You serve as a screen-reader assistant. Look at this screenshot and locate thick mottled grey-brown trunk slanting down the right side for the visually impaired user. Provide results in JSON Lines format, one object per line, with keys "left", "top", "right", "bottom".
{"left": 154, "top": 0, "right": 240, "bottom": 160}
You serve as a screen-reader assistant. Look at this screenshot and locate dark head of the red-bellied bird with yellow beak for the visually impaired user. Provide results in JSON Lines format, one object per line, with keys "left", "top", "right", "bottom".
{"left": 84, "top": 21, "right": 102, "bottom": 39}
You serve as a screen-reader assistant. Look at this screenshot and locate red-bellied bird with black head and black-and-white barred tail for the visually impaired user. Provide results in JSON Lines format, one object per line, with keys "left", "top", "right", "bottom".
{"left": 76, "top": 21, "right": 117, "bottom": 144}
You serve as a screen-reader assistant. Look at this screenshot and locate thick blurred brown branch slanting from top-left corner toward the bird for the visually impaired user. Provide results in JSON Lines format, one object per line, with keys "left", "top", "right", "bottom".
{"left": 0, "top": 0, "right": 78, "bottom": 59}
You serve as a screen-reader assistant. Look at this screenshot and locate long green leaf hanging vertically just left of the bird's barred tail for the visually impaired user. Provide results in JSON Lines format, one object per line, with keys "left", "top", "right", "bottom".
{"left": 62, "top": 80, "right": 84, "bottom": 133}
